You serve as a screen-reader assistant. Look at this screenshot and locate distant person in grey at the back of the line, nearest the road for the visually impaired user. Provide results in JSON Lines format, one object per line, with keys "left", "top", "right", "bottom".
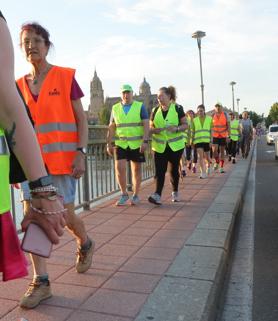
{"left": 240, "top": 111, "right": 253, "bottom": 158}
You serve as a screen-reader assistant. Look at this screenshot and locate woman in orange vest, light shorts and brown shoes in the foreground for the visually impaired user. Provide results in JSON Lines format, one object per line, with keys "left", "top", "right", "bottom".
{"left": 17, "top": 23, "right": 94, "bottom": 308}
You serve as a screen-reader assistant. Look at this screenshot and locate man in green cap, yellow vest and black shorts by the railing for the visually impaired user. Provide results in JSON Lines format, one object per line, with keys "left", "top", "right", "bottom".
{"left": 107, "top": 84, "right": 149, "bottom": 206}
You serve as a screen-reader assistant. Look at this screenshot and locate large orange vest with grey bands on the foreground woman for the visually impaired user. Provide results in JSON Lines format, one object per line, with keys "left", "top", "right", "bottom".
{"left": 17, "top": 66, "right": 78, "bottom": 175}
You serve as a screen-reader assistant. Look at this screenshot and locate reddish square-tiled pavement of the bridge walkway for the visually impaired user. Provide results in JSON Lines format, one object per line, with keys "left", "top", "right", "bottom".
{"left": 0, "top": 164, "right": 235, "bottom": 321}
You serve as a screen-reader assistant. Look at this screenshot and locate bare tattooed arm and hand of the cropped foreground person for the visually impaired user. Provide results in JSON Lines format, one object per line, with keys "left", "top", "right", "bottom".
{"left": 0, "top": 18, "right": 65, "bottom": 243}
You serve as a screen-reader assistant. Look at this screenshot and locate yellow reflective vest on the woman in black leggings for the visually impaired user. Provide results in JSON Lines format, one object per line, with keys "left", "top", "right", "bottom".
{"left": 152, "top": 104, "right": 184, "bottom": 153}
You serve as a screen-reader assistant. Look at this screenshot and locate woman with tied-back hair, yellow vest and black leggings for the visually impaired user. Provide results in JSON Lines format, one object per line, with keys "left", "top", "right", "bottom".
{"left": 148, "top": 86, "right": 188, "bottom": 205}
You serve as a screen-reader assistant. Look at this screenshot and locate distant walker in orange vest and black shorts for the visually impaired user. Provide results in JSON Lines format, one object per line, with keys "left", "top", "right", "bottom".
{"left": 212, "top": 103, "right": 230, "bottom": 173}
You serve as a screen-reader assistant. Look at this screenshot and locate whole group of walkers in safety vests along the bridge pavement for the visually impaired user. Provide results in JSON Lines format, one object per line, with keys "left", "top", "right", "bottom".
{"left": 0, "top": 11, "right": 254, "bottom": 308}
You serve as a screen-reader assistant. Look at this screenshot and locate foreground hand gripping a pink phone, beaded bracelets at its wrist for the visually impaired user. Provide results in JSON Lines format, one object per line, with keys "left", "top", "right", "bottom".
{"left": 21, "top": 199, "right": 67, "bottom": 244}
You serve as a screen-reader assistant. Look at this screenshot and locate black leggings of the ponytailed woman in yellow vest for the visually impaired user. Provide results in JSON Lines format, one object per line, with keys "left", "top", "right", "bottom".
{"left": 154, "top": 145, "right": 184, "bottom": 195}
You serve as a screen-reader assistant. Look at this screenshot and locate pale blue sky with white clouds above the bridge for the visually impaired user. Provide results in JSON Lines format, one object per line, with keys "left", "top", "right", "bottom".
{"left": 0, "top": 0, "right": 278, "bottom": 115}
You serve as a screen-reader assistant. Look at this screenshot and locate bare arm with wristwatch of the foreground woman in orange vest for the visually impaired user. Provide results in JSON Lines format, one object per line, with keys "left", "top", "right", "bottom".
{"left": 71, "top": 99, "right": 88, "bottom": 178}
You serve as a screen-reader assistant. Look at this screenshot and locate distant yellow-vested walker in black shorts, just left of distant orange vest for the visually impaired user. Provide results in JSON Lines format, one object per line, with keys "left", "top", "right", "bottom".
{"left": 192, "top": 105, "right": 212, "bottom": 179}
